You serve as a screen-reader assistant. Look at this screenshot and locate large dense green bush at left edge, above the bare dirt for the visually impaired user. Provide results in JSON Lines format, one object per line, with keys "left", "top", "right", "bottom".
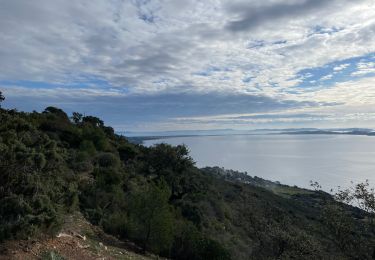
{"left": 0, "top": 111, "right": 77, "bottom": 239}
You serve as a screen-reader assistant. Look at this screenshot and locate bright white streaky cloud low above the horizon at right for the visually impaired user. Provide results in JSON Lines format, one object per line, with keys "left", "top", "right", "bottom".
{"left": 167, "top": 77, "right": 375, "bottom": 129}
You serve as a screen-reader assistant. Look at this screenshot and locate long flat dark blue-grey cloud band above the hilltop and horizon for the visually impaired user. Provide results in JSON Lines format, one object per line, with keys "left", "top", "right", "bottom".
{"left": 4, "top": 88, "right": 319, "bottom": 128}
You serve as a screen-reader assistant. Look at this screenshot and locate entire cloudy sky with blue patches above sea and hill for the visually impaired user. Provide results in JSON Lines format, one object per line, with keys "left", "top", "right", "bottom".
{"left": 0, "top": 0, "right": 375, "bottom": 131}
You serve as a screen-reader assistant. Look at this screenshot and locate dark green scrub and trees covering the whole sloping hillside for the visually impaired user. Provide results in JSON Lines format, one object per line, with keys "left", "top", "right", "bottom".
{"left": 0, "top": 105, "right": 375, "bottom": 259}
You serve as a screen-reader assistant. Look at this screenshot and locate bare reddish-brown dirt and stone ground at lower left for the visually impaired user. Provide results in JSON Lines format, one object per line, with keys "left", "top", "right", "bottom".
{"left": 0, "top": 213, "right": 160, "bottom": 260}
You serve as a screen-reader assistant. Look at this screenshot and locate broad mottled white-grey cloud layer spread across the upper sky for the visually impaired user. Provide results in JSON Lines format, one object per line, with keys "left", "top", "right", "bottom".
{"left": 0, "top": 0, "right": 375, "bottom": 91}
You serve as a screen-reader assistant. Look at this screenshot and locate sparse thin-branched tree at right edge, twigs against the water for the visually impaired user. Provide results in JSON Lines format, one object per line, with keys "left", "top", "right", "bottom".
{"left": 310, "top": 180, "right": 375, "bottom": 259}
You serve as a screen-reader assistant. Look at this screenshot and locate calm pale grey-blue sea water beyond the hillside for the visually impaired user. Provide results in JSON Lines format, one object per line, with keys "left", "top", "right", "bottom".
{"left": 145, "top": 135, "right": 375, "bottom": 191}
